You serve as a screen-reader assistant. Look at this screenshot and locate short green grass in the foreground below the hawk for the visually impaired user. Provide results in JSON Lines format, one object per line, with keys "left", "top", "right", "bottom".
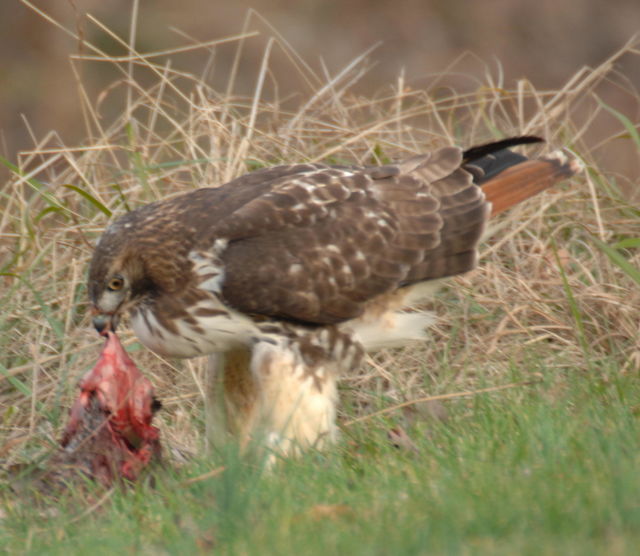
{"left": 2, "top": 362, "right": 640, "bottom": 555}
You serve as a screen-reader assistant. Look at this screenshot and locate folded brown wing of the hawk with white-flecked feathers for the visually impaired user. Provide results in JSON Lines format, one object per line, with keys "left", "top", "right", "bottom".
{"left": 213, "top": 147, "right": 489, "bottom": 324}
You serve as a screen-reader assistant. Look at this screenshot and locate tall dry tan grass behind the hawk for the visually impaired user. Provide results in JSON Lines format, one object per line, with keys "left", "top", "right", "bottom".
{"left": 0, "top": 10, "right": 640, "bottom": 463}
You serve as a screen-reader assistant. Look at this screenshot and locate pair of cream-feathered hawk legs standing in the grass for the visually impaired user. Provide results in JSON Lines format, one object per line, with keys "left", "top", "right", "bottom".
{"left": 205, "top": 324, "right": 362, "bottom": 455}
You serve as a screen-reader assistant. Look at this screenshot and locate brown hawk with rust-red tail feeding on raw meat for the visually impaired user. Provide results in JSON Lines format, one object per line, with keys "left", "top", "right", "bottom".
{"left": 89, "top": 136, "right": 580, "bottom": 453}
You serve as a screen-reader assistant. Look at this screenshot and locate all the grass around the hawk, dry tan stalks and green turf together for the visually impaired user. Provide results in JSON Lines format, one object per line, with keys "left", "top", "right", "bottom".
{"left": 0, "top": 5, "right": 640, "bottom": 554}
